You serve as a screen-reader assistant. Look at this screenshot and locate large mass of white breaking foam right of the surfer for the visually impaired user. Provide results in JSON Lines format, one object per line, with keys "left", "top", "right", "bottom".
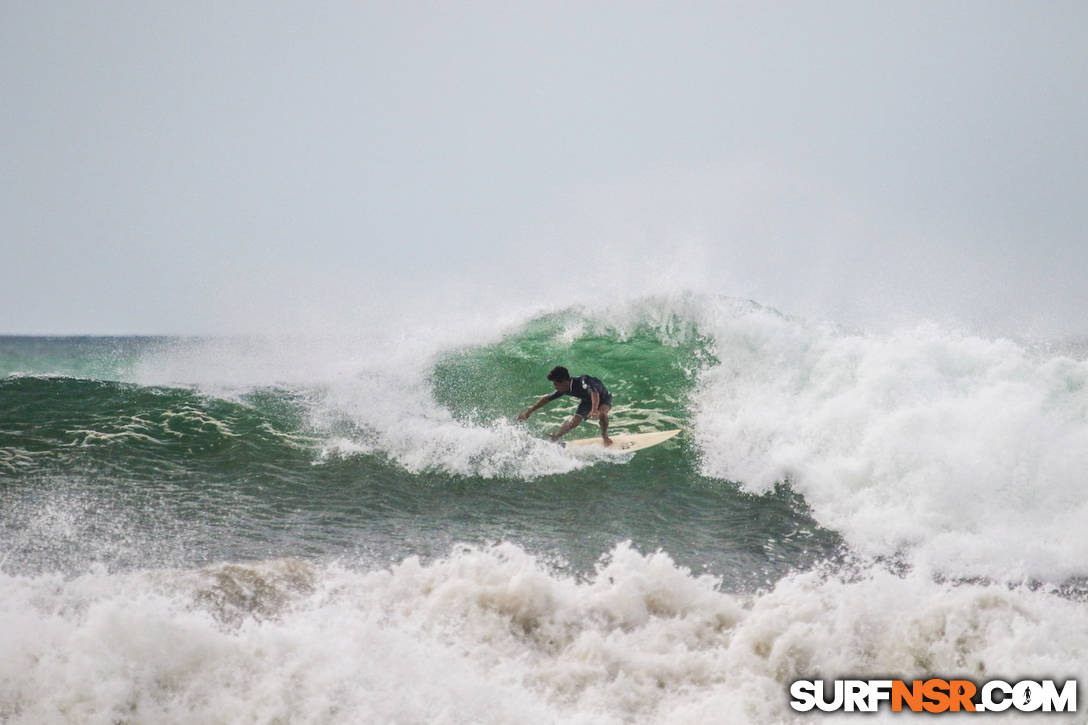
{"left": 695, "top": 302, "right": 1088, "bottom": 580}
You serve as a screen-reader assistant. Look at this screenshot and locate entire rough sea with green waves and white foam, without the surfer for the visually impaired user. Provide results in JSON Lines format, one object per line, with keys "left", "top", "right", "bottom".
{"left": 0, "top": 294, "right": 1088, "bottom": 724}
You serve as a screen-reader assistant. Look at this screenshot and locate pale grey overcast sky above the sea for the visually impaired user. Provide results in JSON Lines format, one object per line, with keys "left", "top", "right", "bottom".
{"left": 0, "top": 0, "right": 1088, "bottom": 335}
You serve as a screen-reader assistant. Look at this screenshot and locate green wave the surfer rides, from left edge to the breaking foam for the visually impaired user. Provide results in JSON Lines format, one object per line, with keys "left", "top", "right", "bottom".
{"left": 0, "top": 313, "right": 838, "bottom": 589}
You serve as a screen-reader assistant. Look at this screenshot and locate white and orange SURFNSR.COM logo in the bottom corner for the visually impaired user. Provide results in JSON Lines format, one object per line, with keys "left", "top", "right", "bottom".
{"left": 790, "top": 678, "right": 1077, "bottom": 713}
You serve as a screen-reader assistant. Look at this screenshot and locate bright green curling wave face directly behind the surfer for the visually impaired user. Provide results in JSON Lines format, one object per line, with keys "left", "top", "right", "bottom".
{"left": 431, "top": 311, "right": 717, "bottom": 435}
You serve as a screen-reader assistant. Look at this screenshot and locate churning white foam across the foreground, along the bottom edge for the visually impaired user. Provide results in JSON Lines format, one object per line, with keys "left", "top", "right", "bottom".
{"left": 0, "top": 543, "right": 1088, "bottom": 724}
